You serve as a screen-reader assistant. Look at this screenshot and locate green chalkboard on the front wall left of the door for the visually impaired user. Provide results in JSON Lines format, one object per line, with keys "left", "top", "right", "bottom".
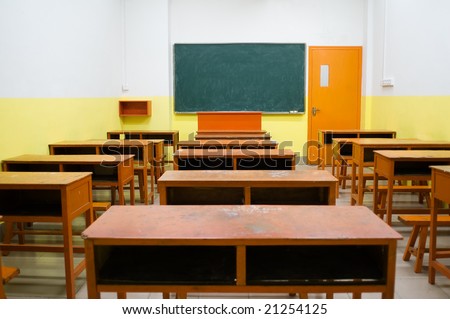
{"left": 174, "top": 43, "right": 305, "bottom": 113}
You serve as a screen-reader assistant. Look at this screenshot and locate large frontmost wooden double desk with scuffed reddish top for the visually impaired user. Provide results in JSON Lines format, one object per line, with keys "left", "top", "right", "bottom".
{"left": 82, "top": 205, "right": 402, "bottom": 298}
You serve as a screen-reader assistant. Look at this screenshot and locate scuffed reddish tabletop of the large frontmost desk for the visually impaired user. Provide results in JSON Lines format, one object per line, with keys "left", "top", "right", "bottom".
{"left": 82, "top": 205, "right": 402, "bottom": 245}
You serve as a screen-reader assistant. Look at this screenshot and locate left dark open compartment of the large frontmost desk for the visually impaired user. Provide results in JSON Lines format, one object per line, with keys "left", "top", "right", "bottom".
{"left": 96, "top": 246, "right": 236, "bottom": 285}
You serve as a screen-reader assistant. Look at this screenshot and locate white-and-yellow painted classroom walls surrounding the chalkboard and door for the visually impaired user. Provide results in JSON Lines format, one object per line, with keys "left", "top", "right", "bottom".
{"left": 0, "top": 0, "right": 450, "bottom": 164}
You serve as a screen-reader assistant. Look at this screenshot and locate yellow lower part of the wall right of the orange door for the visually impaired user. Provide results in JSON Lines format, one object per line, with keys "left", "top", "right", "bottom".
{"left": 367, "top": 96, "right": 450, "bottom": 141}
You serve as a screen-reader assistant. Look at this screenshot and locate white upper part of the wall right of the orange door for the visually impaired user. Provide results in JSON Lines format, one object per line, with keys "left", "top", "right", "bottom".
{"left": 367, "top": 0, "right": 450, "bottom": 96}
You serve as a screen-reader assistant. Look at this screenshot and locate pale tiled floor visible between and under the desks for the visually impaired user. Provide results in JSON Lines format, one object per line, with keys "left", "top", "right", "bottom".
{"left": 3, "top": 166, "right": 450, "bottom": 299}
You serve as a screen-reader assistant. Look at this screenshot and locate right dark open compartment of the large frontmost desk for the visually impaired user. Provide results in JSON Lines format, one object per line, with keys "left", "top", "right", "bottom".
{"left": 246, "top": 245, "right": 387, "bottom": 285}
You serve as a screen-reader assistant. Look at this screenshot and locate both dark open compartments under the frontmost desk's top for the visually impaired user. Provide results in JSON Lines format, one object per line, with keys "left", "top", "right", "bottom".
{"left": 90, "top": 245, "right": 388, "bottom": 286}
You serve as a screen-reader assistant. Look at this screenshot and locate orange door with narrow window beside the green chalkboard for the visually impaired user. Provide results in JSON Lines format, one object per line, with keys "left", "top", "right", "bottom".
{"left": 308, "top": 47, "right": 362, "bottom": 164}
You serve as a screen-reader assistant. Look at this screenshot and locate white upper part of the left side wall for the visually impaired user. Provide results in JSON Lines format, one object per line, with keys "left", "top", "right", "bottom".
{"left": 0, "top": 0, "right": 122, "bottom": 98}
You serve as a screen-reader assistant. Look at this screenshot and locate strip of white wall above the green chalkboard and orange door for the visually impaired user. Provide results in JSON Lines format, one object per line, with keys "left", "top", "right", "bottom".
{"left": 170, "top": 0, "right": 365, "bottom": 45}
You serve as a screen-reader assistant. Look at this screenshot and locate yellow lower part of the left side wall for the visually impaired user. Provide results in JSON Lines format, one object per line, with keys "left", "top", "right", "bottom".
{"left": 0, "top": 98, "right": 120, "bottom": 160}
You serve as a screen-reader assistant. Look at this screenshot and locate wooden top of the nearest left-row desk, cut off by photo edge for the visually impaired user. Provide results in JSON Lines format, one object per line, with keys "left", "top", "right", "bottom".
{"left": 0, "top": 172, "right": 92, "bottom": 187}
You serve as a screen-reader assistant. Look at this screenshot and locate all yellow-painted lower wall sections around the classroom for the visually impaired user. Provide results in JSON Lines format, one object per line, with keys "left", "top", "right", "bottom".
{"left": 0, "top": 96, "right": 450, "bottom": 168}
